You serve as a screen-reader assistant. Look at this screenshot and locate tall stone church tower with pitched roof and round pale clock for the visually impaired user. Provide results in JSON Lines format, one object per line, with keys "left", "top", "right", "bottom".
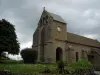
{"left": 33, "top": 8, "right": 67, "bottom": 63}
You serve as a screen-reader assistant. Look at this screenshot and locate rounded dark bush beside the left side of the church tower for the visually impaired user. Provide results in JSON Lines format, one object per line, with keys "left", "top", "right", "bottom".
{"left": 20, "top": 48, "right": 37, "bottom": 63}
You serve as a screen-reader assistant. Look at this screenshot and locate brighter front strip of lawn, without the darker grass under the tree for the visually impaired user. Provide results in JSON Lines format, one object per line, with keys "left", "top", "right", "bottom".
{"left": 0, "top": 64, "right": 56, "bottom": 73}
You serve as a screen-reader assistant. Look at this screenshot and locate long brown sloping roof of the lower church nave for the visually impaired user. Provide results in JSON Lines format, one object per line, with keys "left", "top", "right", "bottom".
{"left": 67, "top": 32, "right": 100, "bottom": 47}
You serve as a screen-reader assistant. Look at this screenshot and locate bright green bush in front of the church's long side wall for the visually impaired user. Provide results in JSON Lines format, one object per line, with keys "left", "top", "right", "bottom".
{"left": 71, "top": 59, "right": 95, "bottom": 75}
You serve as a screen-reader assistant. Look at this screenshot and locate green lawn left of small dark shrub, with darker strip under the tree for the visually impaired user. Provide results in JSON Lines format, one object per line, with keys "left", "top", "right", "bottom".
{"left": 0, "top": 60, "right": 57, "bottom": 73}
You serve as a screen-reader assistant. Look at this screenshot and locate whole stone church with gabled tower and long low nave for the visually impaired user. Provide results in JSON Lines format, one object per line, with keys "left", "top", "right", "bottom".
{"left": 32, "top": 9, "right": 100, "bottom": 68}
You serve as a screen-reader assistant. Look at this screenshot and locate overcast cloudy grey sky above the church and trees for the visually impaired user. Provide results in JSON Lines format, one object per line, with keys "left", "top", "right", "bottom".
{"left": 0, "top": 0, "right": 100, "bottom": 59}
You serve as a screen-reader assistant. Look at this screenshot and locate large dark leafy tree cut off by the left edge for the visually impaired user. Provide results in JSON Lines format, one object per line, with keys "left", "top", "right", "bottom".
{"left": 0, "top": 19, "right": 20, "bottom": 57}
